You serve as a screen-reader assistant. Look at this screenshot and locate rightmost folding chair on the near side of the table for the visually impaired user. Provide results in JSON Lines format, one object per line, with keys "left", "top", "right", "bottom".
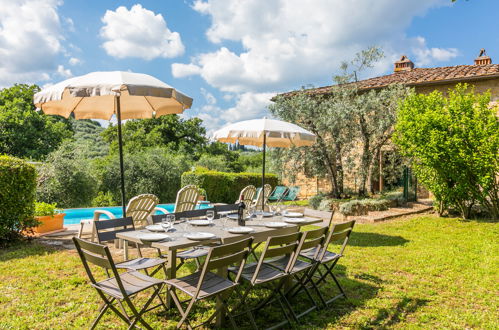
{"left": 293, "top": 220, "right": 355, "bottom": 306}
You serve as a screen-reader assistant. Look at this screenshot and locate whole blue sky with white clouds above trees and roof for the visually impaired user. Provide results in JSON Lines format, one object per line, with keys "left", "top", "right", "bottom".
{"left": 0, "top": 0, "right": 499, "bottom": 131}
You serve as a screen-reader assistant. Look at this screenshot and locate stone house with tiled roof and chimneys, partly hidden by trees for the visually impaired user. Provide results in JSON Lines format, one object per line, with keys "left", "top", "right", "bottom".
{"left": 282, "top": 49, "right": 499, "bottom": 198}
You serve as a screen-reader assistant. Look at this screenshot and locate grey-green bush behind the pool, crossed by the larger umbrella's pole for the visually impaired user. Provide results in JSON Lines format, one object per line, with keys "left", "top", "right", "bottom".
{"left": 95, "top": 148, "right": 190, "bottom": 205}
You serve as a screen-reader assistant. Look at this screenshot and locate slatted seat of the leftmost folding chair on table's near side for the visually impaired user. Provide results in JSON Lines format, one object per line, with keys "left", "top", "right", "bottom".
{"left": 165, "top": 272, "right": 235, "bottom": 299}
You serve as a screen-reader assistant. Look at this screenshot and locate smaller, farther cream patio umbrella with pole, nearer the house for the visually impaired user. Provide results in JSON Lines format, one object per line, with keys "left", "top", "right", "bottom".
{"left": 213, "top": 117, "right": 316, "bottom": 211}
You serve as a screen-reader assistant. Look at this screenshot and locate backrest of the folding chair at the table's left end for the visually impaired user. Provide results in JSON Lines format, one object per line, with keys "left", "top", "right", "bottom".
{"left": 73, "top": 237, "right": 122, "bottom": 288}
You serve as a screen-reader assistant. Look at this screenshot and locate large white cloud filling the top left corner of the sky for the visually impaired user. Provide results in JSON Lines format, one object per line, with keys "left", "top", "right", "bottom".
{"left": 0, "top": 0, "right": 64, "bottom": 86}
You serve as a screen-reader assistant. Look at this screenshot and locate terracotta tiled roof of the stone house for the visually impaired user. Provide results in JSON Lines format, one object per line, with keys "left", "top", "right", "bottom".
{"left": 281, "top": 64, "right": 499, "bottom": 95}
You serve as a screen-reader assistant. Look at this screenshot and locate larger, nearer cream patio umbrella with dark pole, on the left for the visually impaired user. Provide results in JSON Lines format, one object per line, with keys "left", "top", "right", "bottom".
{"left": 34, "top": 71, "right": 192, "bottom": 216}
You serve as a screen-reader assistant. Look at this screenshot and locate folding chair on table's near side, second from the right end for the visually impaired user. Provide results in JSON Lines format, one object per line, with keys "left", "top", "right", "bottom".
{"left": 267, "top": 227, "right": 328, "bottom": 321}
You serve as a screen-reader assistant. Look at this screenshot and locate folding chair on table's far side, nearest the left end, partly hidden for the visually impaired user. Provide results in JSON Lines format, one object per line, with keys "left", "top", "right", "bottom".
{"left": 94, "top": 217, "right": 166, "bottom": 276}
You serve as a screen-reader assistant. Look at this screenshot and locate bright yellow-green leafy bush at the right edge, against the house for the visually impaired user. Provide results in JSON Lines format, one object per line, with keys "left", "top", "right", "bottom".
{"left": 394, "top": 84, "right": 499, "bottom": 219}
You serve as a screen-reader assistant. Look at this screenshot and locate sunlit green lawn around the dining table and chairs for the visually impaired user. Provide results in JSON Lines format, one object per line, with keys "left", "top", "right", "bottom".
{"left": 0, "top": 216, "right": 499, "bottom": 329}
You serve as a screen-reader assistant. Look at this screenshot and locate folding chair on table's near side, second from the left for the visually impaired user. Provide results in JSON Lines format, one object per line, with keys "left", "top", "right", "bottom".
{"left": 229, "top": 232, "right": 302, "bottom": 329}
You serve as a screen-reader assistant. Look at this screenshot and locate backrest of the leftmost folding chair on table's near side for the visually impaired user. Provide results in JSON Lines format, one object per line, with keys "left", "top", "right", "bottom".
{"left": 194, "top": 237, "right": 253, "bottom": 298}
